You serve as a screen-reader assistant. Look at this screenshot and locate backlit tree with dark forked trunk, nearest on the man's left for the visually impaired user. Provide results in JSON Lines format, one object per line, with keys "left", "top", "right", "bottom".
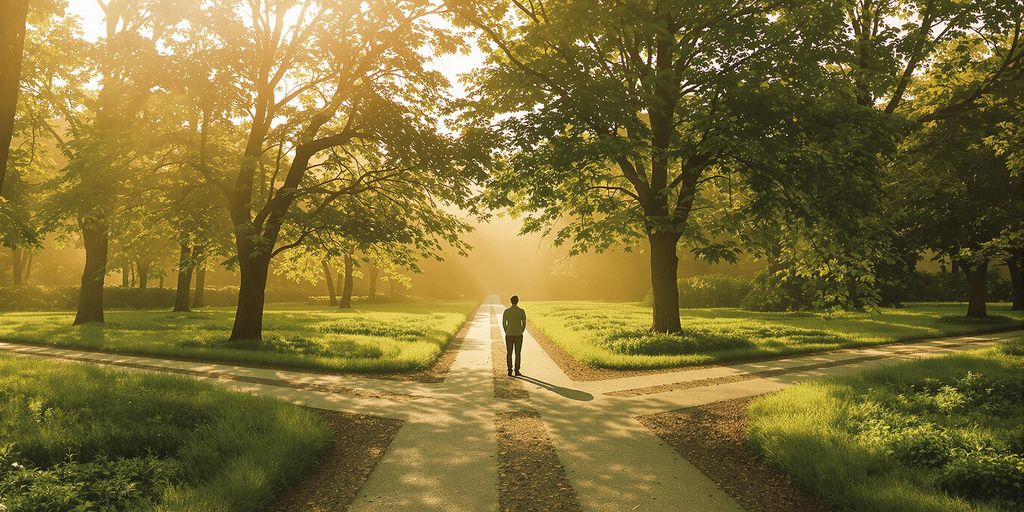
{"left": 195, "top": 0, "right": 478, "bottom": 340}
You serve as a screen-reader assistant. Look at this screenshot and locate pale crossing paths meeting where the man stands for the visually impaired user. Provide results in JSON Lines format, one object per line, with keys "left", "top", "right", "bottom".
{"left": 0, "top": 296, "right": 1021, "bottom": 512}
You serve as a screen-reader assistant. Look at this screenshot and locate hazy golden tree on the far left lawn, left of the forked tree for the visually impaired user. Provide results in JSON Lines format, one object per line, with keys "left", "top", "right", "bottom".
{"left": 34, "top": 0, "right": 190, "bottom": 325}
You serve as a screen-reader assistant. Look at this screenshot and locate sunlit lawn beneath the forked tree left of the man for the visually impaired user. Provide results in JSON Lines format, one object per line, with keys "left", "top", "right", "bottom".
{"left": 0, "top": 301, "right": 475, "bottom": 372}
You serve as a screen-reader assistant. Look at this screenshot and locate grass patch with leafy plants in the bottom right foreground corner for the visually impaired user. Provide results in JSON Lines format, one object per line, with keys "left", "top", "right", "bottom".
{"left": 746, "top": 338, "right": 1024, "bottom": 512}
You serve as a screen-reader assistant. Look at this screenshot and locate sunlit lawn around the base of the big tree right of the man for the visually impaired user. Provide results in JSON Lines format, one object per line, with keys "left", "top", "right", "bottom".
{"left": 523, "top": 301, "right": 1024, "bottom": 370}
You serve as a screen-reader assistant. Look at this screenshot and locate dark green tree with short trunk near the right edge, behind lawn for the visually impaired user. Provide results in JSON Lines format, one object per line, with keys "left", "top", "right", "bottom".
{"left": 897, "top": 32, "right": 1024, "bottom": 317}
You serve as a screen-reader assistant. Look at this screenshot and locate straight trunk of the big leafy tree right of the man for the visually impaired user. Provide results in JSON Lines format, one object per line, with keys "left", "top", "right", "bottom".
{"left": 648, "top": 232, "right": 682, "bottom": 333}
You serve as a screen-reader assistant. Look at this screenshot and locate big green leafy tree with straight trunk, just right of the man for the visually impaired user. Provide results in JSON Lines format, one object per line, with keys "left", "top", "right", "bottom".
{"left": 450, "top": 0, "right": 839, "bottom": 332}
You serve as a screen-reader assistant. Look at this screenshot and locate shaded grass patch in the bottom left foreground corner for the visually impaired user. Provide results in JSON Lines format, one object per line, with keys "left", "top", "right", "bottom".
{"left": 0, "top": 356, "right": 331, "bottom": 512}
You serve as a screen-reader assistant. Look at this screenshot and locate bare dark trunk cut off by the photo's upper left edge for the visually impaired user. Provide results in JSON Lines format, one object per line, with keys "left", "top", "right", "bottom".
{"left": 0, "top": 0, "right": 29, "bottom": 194}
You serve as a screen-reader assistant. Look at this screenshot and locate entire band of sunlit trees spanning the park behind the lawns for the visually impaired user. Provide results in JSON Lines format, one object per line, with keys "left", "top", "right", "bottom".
{"left": 0, "top": 0, "right": 1024, "bottom": 340}
